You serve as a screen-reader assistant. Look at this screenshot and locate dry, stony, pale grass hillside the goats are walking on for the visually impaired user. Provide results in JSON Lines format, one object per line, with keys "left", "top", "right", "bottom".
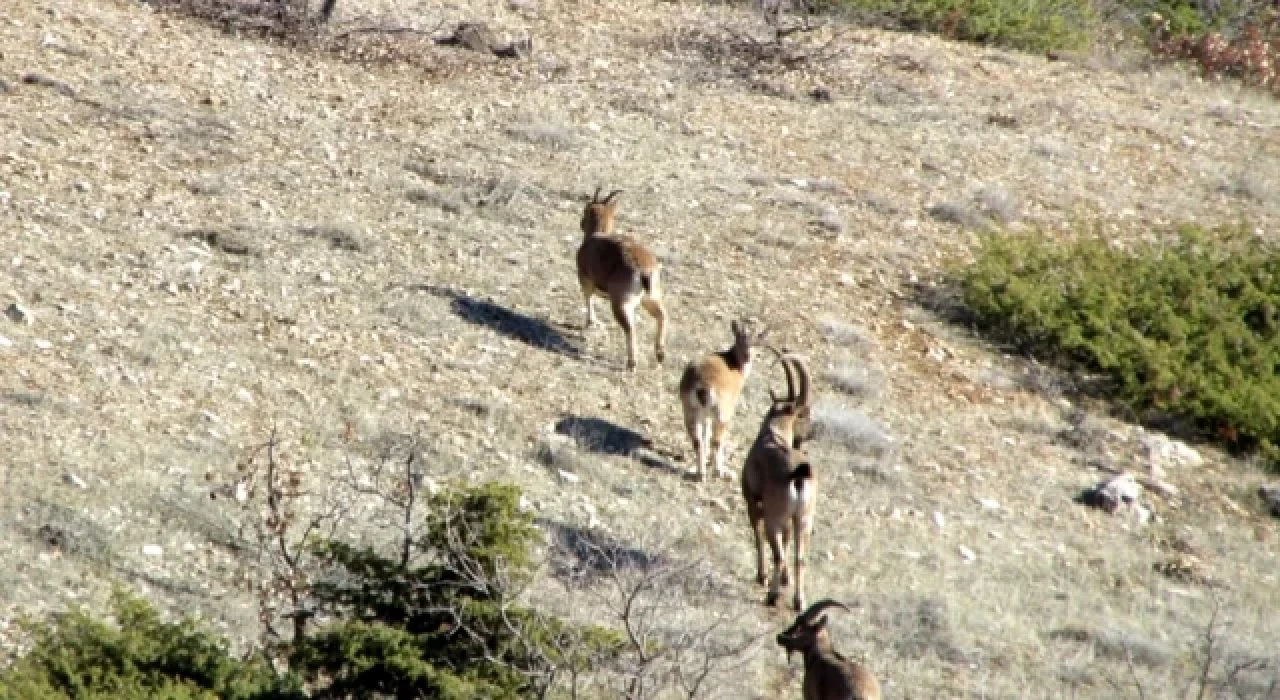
{"left": 0, "top": 0, "right": 1280, "bottom": 697}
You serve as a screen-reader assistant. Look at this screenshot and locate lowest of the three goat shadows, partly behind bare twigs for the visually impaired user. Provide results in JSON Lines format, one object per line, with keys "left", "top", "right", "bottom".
{"left": 536, "top": 518, "right": 669, "bottom": 586}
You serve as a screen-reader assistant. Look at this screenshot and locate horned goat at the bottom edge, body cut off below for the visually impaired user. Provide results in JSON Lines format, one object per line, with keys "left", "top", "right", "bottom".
{"left": 777, "top": 599, "right": 881, "bottom": 700}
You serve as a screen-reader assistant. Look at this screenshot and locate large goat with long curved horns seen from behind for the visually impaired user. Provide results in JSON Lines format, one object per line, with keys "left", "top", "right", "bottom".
{"left": 742, "top": 346, "right": 818, "bottom": 610}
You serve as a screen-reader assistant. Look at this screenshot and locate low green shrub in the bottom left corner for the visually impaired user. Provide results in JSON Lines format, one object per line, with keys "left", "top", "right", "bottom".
{"left": 0, "top": 591, "right": 302, "bottom": 700}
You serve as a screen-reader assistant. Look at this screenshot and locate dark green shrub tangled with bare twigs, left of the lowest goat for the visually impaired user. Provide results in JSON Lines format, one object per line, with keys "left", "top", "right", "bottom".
{"left": 291, "top": 484, "right": 621, "bottom": 700}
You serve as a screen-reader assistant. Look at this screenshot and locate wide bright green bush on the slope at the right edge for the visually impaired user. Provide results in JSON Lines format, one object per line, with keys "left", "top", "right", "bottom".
{"left": 959, "top": 228, "right": 1280, "bottom": 459}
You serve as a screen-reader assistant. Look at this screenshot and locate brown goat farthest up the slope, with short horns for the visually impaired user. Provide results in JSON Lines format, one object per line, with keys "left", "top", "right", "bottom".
{"left": 577, "top": 187, "right": 667, "bottom": 371}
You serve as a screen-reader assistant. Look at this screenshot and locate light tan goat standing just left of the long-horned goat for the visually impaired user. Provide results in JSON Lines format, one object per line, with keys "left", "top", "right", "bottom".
{"left": 680, "top": 321, "right": 767, "bottom": 480}
